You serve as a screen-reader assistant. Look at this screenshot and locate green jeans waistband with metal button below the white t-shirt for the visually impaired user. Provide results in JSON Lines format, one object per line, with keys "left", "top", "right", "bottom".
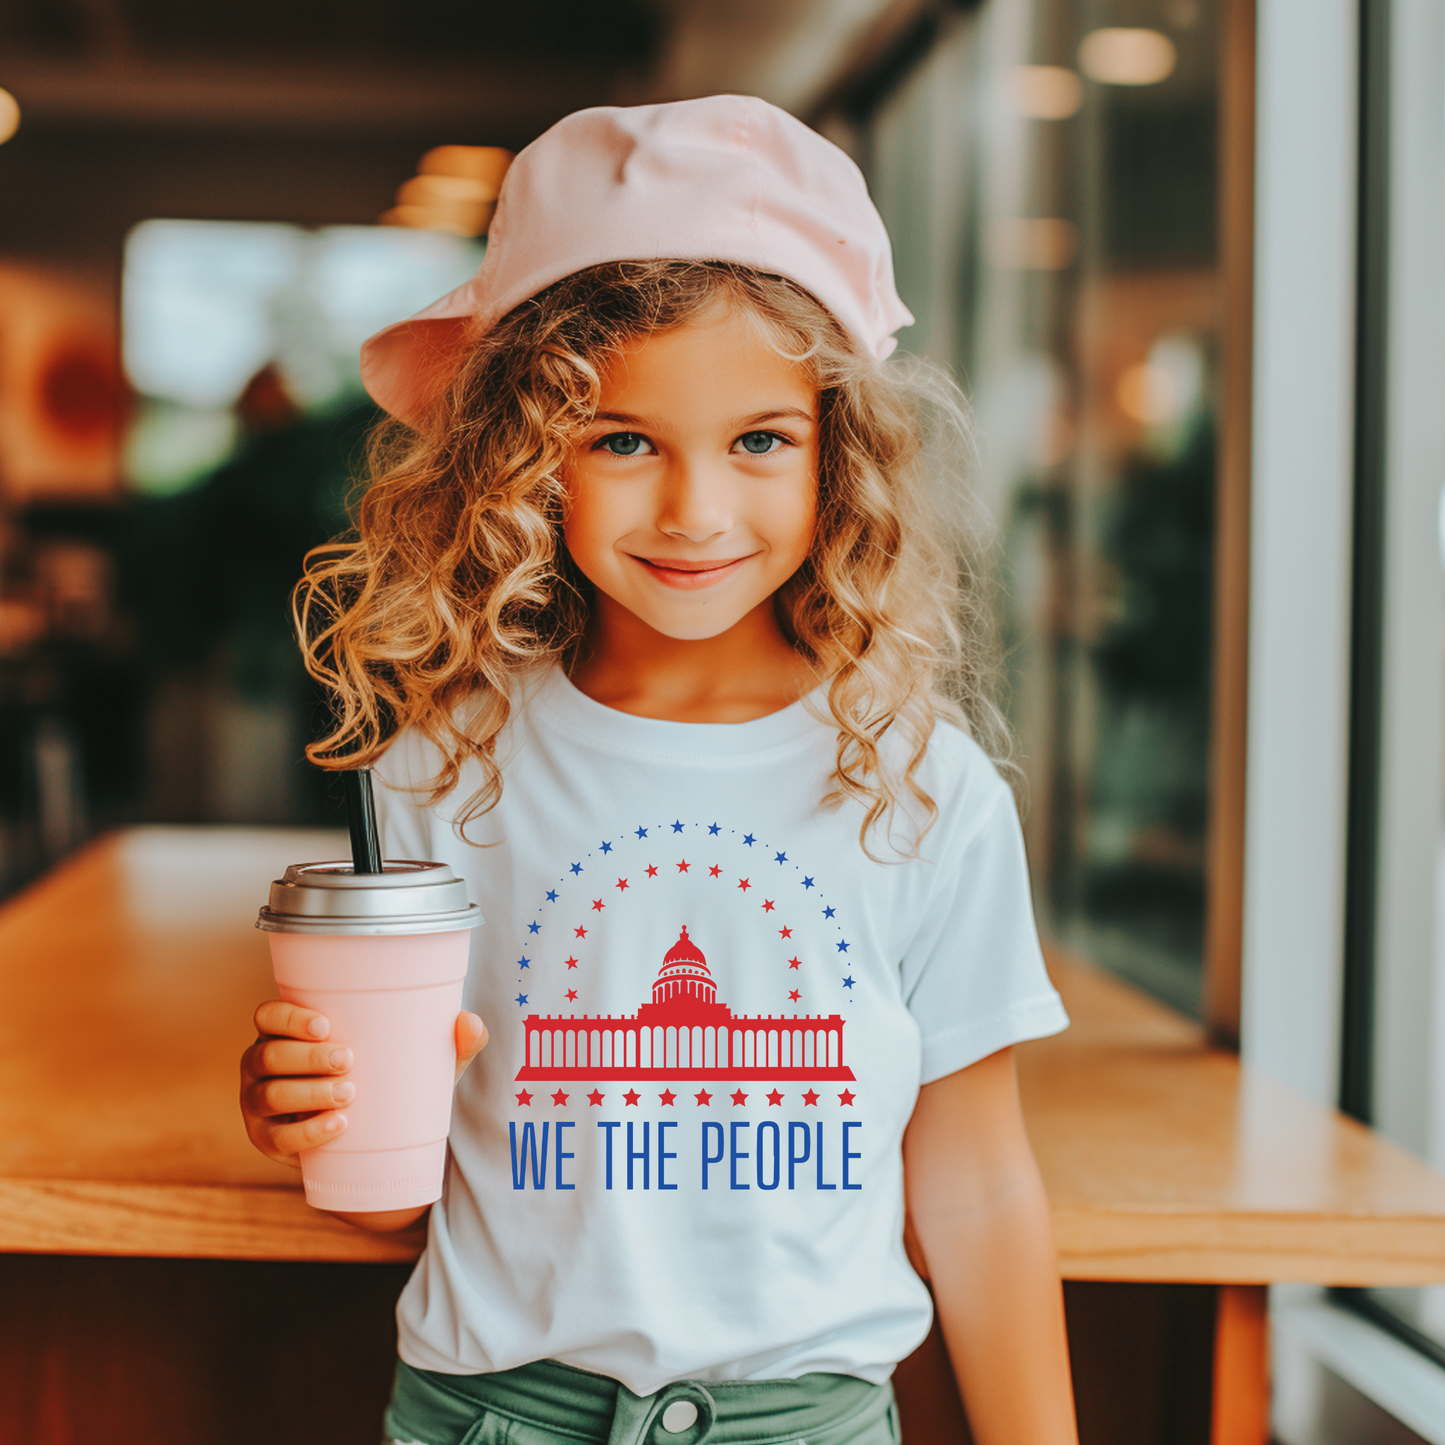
{"left": 384, "top": 1360, "right": 899, "bottom": 1445}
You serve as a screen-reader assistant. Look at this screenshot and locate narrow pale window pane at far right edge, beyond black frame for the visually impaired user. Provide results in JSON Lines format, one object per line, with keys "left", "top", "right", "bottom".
{"left": 1341, "top": 4, "right": 1445, "bottom": 1364}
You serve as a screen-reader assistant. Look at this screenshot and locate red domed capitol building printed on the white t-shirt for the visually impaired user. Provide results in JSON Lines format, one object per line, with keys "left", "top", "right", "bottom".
{"left": 517, "top": 926, "right": 854, "bottom": 1081}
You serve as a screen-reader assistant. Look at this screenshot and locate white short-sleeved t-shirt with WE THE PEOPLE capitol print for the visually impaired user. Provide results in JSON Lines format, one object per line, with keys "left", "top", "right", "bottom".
{"left": 377, "top": 670, "right": 1068, "bottom": 1394}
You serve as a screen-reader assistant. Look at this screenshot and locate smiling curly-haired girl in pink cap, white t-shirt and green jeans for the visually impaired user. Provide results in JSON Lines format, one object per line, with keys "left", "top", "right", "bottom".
{"left": 241, "top": 97, "right": 1075, "bottom": 1445}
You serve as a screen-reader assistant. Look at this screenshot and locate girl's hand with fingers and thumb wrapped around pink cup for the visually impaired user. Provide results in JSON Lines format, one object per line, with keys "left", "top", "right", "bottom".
{"left": 241, "top": 998, "right": 487, "bottom": 1169}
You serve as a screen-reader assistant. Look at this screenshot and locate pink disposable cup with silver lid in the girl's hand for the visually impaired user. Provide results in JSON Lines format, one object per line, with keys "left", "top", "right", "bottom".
{"left": 256, "top": 861, "right": 481, "bottom": 1212}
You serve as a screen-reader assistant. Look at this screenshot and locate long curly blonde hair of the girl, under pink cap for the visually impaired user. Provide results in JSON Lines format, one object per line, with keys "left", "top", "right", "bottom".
{"left": 292, "top": 262, "right": 1007, "bottom": 848}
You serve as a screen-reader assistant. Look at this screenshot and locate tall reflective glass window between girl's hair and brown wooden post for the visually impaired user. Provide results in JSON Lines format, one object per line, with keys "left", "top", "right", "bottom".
{"left": 854, "top": 0, "right": 1221, "bottom": 1013}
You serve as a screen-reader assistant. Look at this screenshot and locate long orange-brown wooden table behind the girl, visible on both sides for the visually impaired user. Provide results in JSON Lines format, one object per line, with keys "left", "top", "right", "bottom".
{"left": 0, "top": 828, "right": 1445, "bottom": 1445}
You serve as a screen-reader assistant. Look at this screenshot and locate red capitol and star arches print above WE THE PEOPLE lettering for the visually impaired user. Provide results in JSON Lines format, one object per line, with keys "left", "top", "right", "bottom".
{"left": 516, "top": 818, "right": 857, "bottom": 1108}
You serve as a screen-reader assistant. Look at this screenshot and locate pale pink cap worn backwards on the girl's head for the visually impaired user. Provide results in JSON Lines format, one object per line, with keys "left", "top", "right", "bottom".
{"left": 361, "top": 95, "right": 913, "bottom": 420}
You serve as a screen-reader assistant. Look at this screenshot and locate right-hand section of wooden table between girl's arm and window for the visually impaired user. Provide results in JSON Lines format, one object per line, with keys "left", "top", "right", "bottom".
{"left": 1019, "top": 958, "right": 1445, "bottom": 1445}
